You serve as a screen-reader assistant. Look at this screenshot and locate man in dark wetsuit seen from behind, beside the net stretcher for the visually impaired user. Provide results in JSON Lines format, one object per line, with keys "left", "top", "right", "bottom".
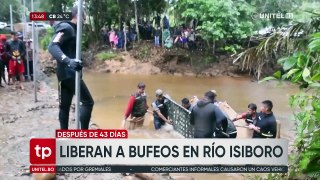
{"left": 190, "top": 91, "right": 226, "bottom": 138}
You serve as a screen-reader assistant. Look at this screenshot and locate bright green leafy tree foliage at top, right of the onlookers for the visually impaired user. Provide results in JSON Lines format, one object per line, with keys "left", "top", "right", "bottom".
{"left": 176, "top": 0, "right": 255, "bottom": 52}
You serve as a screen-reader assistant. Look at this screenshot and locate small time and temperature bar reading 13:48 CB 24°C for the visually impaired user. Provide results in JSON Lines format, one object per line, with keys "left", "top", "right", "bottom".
{"left": 30, "top": 12, "right": 72, "bottom": 21}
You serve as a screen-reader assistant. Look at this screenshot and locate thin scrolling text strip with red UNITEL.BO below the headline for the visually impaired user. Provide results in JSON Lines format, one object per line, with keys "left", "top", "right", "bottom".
{"left": 30, "top": 165, "right": 288, "bottom": 173}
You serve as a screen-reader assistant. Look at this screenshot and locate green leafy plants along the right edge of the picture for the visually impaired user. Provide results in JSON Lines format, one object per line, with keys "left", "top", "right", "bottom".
{"left": 262, "top": 33, "right": 320, "bottom": 178}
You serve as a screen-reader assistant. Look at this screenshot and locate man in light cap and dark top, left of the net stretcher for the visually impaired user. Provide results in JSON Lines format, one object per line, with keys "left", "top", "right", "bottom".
{"left": 152, "top": 89, "right": 172, "bottom": 130}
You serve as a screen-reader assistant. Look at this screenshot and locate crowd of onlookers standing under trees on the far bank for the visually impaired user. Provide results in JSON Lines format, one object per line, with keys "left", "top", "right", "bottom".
{"left": 100, "top": 15, "right": 196, "bottom": 49}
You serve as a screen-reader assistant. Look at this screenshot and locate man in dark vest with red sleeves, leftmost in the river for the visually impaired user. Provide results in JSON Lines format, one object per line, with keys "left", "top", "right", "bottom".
{"left": 124, "top": 82, "right": 148, "bottom": 120}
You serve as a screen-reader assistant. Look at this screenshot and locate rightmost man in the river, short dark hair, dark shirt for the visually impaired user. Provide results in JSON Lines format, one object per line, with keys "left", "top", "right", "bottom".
{"left": 249, "top": 100, "right": 277, "bottom": 138}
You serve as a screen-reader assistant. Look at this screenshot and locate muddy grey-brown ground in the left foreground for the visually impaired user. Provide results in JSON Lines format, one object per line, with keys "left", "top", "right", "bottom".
{"left": 0, "top": 82, "right": 122, "bottom": 179}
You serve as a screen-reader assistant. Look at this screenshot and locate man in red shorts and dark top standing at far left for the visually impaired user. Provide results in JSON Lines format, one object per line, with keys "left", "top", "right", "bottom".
{"left": 6, "top": 32, "right": 26, "bottom": 89}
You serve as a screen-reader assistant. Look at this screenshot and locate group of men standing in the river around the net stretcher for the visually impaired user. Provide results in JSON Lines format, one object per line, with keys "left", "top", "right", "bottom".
{"left": 124, "top": 83, "right": 277, "bottom": 138}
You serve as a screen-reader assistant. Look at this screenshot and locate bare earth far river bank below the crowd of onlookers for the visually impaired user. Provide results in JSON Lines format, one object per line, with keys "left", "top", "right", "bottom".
{"left": 40, "top": 44, "right": 248, "bottom": 77}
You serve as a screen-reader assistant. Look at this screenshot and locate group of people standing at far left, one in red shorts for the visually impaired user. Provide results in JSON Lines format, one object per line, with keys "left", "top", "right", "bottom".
{"left": 0, "top": 31, "right": 30, "bottom": 90}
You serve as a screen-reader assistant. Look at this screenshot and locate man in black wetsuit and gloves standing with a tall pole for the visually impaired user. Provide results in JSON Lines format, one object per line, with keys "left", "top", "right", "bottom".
{"left": 48, "top": 6, "right": 94, "bottom": 129}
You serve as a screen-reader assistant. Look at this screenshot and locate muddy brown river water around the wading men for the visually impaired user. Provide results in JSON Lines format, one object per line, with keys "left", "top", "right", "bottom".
{"left": 49, "top": 72, "right": 298, "bottom": 179}
